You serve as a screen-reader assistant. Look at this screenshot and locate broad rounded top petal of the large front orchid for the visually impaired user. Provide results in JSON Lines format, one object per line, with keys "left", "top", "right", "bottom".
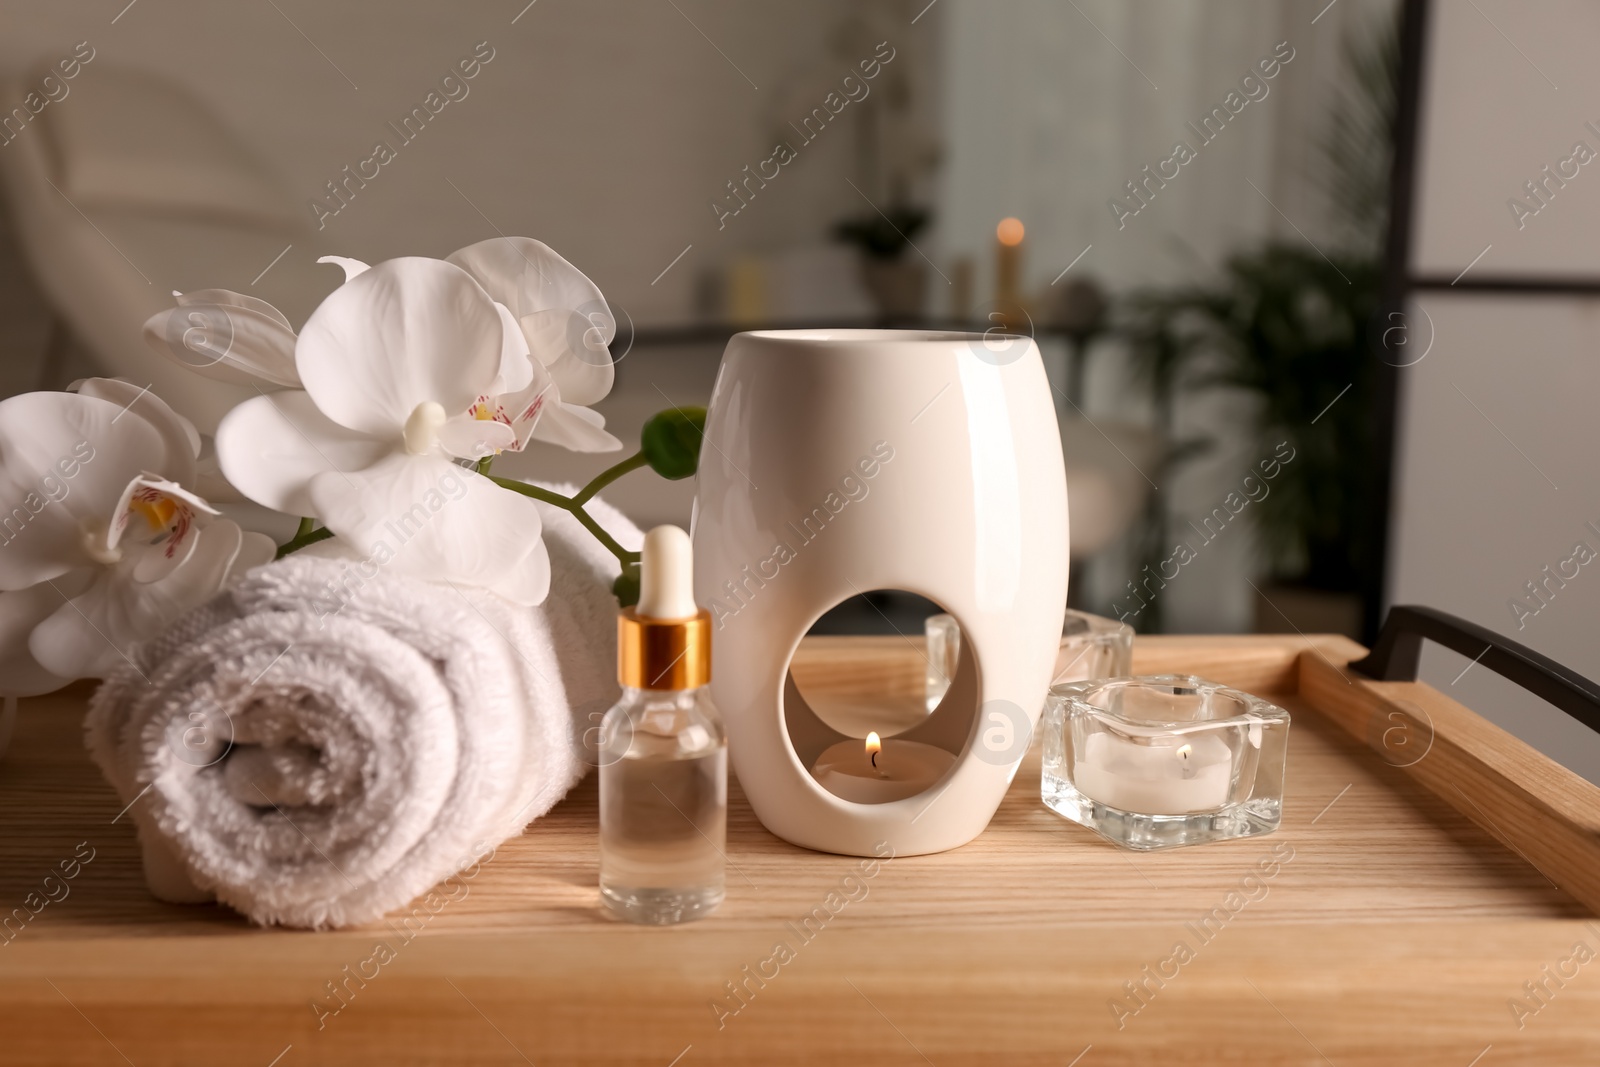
{"left": 297, "top": 258, "right": 502, "bottom": 435}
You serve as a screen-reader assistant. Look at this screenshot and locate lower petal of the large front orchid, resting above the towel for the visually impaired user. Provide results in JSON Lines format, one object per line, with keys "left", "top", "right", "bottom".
{"left": 310, "top": 453, "right": 550, "bottom": 605}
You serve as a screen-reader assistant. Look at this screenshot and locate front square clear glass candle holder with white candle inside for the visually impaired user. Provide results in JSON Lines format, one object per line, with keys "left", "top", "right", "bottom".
{"left": 1040, "top": 675, "right": 1290, "bottom": 849}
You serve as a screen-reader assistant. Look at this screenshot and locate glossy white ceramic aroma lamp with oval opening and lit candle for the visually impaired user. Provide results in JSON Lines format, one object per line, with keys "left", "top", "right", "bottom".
{"left": 693, "top": 330, "right": 1067, "bottom": 856}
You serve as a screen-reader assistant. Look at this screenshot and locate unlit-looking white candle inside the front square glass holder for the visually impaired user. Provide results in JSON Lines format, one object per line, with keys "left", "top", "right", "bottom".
{"left": 1072, "top": 731, "right": 1234, "bottom": 816}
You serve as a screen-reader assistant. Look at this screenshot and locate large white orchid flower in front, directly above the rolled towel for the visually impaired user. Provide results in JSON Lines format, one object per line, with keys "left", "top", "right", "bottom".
{"left": 216, "top": 258, "right": 550, "bottom": 605}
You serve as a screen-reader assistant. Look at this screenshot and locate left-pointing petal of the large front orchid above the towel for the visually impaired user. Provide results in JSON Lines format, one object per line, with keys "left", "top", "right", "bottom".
{"left": 216, "top": 390, "right": 398, "bottom": 515}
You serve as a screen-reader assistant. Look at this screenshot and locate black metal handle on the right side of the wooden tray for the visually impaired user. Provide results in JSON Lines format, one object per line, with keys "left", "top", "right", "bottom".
{"left": 1350, "top": 605, "right": 1600, "bottom": 733}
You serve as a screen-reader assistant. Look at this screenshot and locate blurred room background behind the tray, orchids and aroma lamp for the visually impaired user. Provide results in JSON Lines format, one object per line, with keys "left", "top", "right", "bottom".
{"left": 0, "top": 0, "right": 1600, "bottom": 777}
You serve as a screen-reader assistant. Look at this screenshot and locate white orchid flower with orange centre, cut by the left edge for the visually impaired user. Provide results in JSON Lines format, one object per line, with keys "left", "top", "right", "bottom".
{"left": 0, "top": 379, "right": 274, "bottom": 696}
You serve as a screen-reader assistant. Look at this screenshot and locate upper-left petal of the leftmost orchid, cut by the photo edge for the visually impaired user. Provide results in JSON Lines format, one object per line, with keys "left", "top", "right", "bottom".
{"left": 0, "top": 392, "right": 169, "bottom": 590}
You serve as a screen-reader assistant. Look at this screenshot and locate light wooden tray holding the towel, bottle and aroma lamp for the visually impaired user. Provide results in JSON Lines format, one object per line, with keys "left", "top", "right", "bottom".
{"left": 0, "top": 637, "right": 1600, "bottom": 1067}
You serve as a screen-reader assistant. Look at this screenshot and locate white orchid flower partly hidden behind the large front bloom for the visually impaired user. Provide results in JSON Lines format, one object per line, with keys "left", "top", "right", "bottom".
{"left": 318, "top": 237, "right": 622, "bottom": 453}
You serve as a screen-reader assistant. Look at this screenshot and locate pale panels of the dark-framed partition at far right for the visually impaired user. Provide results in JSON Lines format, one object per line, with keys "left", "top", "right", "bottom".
{"left": 1389, "top": 0, "right": 1600, "bottom": 781}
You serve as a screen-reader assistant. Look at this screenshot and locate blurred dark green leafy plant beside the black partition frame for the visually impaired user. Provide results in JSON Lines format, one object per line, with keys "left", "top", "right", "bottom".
{"left": 1120, "top": 22, "right": 1400, "bottom": 614}
